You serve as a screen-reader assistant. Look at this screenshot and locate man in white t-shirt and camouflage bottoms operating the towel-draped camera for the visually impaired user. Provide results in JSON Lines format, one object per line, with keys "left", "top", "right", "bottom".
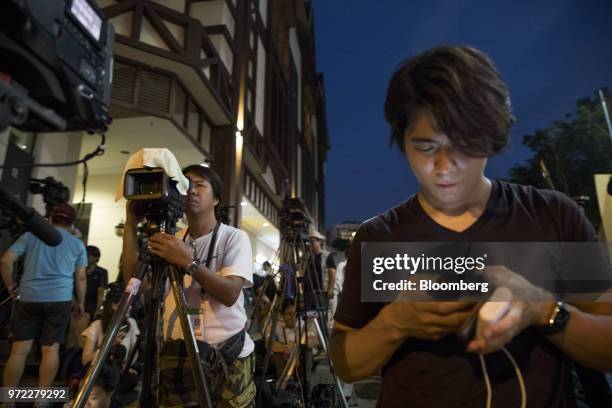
{"left": 123, "top": 165, "right": 255, "bottom": 407}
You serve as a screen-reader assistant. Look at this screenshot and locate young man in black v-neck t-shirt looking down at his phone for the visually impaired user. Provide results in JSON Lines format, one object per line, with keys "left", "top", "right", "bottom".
{"left": 331, "top": 47, "right": 612, "bottom": 407}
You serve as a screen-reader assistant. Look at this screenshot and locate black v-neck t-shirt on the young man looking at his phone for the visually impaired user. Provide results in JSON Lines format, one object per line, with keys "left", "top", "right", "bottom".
{"left": 334, "top": 182, "right": 596, "bottom": 408}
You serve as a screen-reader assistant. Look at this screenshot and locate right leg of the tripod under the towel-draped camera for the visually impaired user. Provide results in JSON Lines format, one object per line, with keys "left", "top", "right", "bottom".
{"left": 167, "top": 265, "right": 213, "bottom": 408}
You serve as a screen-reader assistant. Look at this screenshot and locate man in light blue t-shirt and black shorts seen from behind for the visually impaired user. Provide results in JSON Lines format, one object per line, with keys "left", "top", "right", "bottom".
{"left": 0, "top": 204, "right": 87, "bottom": 387}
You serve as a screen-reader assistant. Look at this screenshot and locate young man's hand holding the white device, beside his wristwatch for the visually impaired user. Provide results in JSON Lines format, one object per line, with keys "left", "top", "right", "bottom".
{"left": 467, "top": 266, "right": 554, "bottom": 354}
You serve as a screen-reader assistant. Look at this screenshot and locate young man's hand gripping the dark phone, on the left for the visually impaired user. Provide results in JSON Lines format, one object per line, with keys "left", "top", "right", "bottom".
{"left": 383, "top": 301, "right": 474, "bottom": 340}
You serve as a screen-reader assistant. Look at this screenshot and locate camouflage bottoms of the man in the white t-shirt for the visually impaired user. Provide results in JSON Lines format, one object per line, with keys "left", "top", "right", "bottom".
{"left": 160, "top": 353, "right": 256, "bottom": 408}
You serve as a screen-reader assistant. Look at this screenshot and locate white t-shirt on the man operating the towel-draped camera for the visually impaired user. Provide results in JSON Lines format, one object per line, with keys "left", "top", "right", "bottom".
{"left": 164, "top": 224, "right": 255, "bottom": 357}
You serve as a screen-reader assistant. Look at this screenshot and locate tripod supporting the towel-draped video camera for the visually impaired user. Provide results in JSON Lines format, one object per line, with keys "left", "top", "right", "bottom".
{"left": 73, "top": 225, "right": 213, "bottom": 408}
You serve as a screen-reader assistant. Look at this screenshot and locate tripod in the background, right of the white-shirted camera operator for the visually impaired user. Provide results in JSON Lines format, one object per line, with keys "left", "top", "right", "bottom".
{"left": 251, "top": 228, "right": 348, "bottom": 408}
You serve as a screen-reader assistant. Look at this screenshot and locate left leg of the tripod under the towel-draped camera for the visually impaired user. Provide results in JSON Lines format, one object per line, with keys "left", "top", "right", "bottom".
{"left": 73, "top": 265, "right": 147, "bottom": 408}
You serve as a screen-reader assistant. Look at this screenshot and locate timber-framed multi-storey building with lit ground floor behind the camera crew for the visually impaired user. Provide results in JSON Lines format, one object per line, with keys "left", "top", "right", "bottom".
{"left": 0, "top": 0, "right": 330, "bottom": 275}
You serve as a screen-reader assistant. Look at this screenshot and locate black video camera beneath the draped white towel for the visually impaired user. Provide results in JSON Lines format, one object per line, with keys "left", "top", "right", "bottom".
{"left": 123, "top": 167, "right": 185, "bottom": 235}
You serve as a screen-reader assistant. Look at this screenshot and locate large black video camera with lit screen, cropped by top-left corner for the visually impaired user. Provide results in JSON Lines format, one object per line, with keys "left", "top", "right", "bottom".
{"left": 0, "top": 0, "right": 115, "bottom": 133}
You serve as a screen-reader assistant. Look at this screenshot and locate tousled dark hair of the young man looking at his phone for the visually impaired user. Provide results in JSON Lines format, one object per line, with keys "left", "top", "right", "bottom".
{"left": 385, "top": 46, "right": 514, "bottom": 157}
